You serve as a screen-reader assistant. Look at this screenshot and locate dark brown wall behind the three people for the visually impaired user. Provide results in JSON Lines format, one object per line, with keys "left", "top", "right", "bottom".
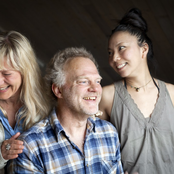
{"left": 0, "top": 0, "right": 174, "bottom": 85}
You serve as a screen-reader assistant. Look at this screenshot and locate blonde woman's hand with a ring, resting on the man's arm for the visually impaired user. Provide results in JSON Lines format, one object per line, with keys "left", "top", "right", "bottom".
{"left": 1, "top": 132, "right": 24, "bottom": 160}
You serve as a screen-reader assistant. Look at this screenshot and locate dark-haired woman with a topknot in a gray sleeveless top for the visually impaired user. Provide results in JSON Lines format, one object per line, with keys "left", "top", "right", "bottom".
{"left": 100, "top": 9, "right": 174, "bottom": 174}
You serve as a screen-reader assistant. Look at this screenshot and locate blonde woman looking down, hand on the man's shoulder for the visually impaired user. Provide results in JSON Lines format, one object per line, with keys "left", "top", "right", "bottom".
{"left": 0, "top": 31, "right": 49, "bottom": 172}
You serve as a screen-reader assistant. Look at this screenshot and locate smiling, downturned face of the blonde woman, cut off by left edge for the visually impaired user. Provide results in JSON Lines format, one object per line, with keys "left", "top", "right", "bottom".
{"left": 0, "top": 63, "right": 22, "bottom": 101}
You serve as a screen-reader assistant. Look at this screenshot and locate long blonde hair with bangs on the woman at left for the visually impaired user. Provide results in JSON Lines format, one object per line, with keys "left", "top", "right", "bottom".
{"left": 0, "top": 31, "right": 50, "bottom": 130}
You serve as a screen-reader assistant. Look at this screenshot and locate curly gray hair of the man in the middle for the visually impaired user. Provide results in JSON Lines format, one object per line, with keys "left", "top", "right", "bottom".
{"left": 45, "top": 47, "right": 98, "bottom": 102}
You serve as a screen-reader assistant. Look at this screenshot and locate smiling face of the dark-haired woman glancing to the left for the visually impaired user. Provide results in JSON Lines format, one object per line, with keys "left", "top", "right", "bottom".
{"left": 108, "top": 31, "right": 144, "bottom": 77}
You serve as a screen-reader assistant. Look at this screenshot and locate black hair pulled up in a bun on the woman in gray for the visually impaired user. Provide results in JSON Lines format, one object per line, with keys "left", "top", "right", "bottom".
{"left": 111, "top": 8, "right": 154, "bottom": 73}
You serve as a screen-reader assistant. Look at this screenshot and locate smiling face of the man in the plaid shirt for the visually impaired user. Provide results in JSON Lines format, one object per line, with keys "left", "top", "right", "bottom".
{"left": 62, "top": 57, "right": 102, "bottom": 115}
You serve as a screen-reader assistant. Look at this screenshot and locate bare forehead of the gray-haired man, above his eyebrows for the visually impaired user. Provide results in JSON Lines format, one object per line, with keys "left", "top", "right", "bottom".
{"left": 64, "top": 57, "right": 99, "bottom": 76}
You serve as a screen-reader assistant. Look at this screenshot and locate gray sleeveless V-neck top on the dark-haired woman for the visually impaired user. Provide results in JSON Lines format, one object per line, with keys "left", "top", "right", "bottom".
{"left": 111, "top": 80, "right": 174, "bottom": 174}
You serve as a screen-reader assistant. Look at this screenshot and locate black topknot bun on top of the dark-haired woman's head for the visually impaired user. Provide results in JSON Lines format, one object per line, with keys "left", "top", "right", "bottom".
{"left": 119, "top": 8, "right": 148, "bottom": 32}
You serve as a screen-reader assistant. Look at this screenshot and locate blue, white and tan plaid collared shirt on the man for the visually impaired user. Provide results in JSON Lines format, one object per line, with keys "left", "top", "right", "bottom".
{"left": 9, "top": 110, "right": 123, "bottom": 174}
